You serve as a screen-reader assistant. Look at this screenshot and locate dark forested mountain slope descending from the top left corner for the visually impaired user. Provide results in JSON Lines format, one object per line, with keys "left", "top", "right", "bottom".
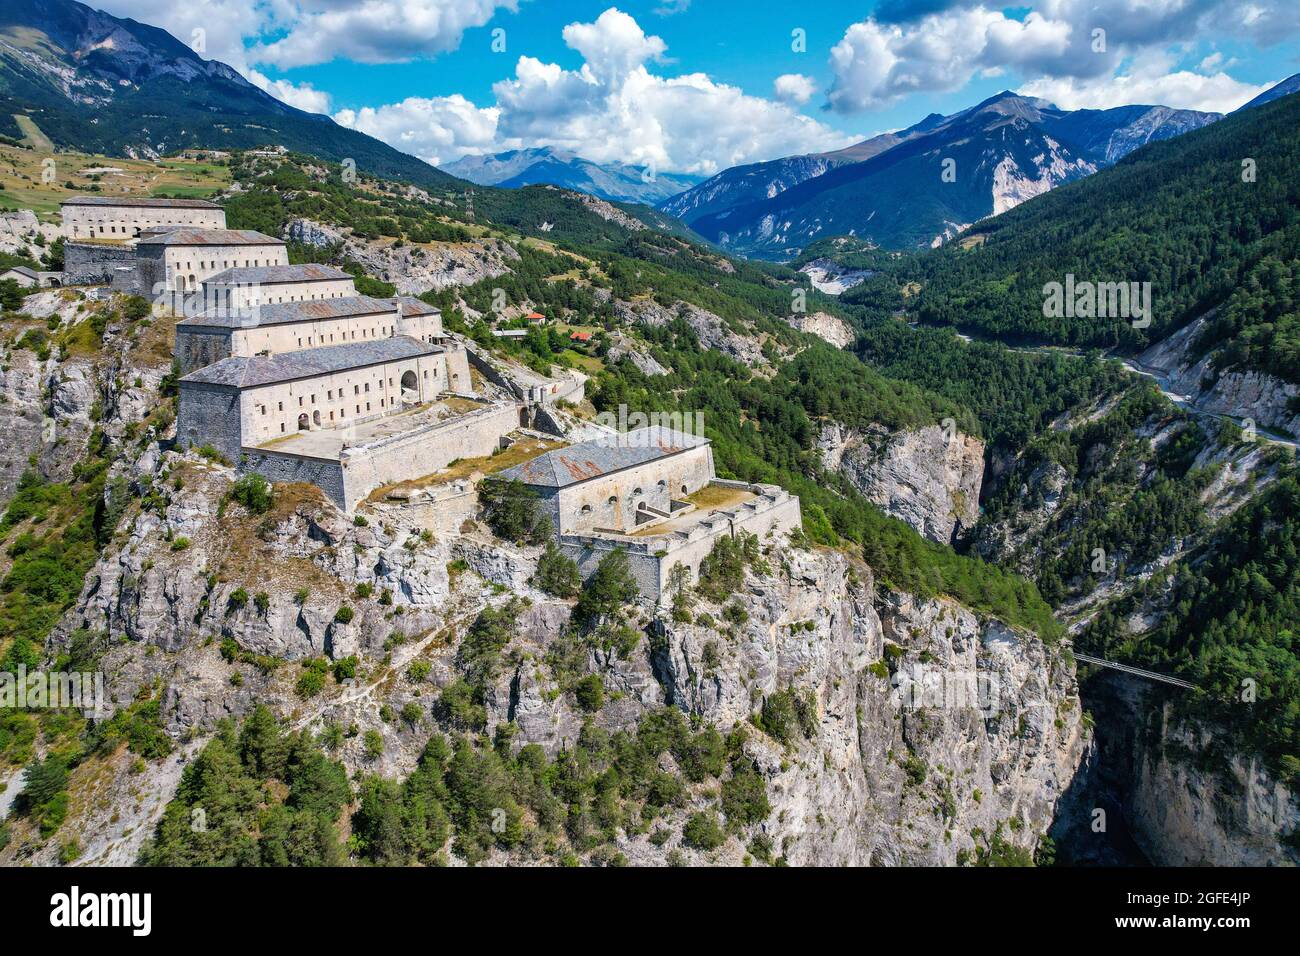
{"left": 0, "top": 0, "right": 459, "bottom": 187}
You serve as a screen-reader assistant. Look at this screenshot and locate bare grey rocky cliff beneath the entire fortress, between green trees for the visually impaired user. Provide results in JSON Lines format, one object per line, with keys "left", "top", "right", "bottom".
{"left": 7, "top": 421, "right": 1089, "bottom": 865}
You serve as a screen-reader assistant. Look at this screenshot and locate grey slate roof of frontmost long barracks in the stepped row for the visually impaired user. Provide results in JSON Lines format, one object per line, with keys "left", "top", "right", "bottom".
{"left": 181, "top": 336, "right": 443, "bottom": 389}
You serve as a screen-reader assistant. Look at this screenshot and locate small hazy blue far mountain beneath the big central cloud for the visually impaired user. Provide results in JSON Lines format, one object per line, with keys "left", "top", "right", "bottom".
{"left": 442, "top": 146, "right": 702, "bottom": 206}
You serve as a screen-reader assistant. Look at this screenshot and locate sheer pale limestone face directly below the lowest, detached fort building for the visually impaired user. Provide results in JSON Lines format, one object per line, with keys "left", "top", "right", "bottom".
{"left": 655, "top": 550, "right": 1089, "bottom": 865}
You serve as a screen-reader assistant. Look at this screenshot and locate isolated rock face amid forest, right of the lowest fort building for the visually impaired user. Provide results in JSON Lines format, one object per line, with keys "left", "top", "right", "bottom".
{"left": 818, "top": 424, "right": 984, "bottom": 544}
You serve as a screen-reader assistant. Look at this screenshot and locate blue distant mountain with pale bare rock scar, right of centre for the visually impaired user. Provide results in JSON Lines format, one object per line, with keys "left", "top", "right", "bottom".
{"left": 660, "top": 92, "right": 1221, "bottom": 259}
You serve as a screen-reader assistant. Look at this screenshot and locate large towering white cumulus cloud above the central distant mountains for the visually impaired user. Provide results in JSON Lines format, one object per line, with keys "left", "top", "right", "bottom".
{"left": 334, "top": 8, "right": 857, "bottom": 174}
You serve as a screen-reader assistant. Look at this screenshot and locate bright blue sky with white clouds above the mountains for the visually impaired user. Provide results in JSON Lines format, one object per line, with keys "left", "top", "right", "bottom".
{"left": 101, "top": 0, "right": 1300, "bottom": 174}
